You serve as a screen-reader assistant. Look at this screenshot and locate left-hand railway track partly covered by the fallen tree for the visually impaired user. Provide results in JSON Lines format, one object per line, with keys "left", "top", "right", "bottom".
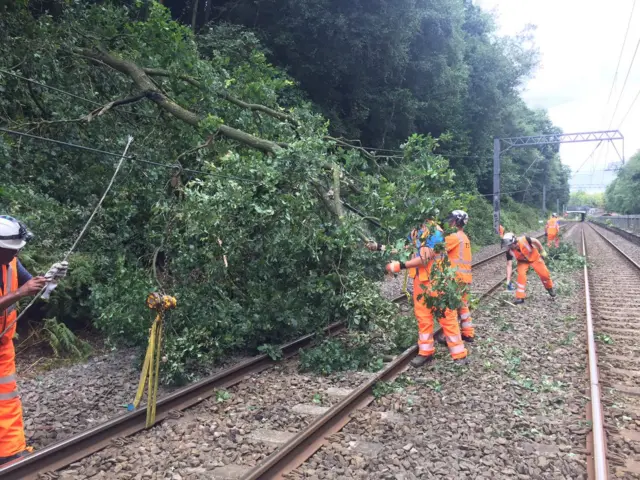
{"left": 0, "top": 226, "right": 568, "bottom": 479}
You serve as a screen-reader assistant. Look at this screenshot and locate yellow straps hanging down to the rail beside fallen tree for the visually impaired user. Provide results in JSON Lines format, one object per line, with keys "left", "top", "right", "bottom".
{"left": 129, "top": 293, "right": 176, "bottom": 428}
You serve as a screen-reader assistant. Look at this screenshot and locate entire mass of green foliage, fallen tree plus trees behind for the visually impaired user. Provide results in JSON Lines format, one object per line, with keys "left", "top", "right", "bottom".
{"left": 0, "top": 0, "right": 566, "bottom": 379}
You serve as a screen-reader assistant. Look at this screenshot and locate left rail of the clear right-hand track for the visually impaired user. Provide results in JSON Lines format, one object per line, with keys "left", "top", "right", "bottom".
{"left": 581, "top": 227, "right": 608, "bottom": 480}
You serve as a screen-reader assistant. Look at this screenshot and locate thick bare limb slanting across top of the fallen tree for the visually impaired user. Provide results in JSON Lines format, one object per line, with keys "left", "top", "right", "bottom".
{"left": 73, "top": 48, "right": 281, "bottom": 154}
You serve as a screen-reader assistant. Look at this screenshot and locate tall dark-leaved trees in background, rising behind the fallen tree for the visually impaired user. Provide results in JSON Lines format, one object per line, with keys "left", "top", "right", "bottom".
{"left": 165, "top": 0, "right": 569, "bottom": 208}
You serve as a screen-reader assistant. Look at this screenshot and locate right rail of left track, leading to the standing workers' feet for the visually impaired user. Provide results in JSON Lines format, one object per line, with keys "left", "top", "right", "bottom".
{"left": 242, "top": 272, "right": 504, "bottom": 480}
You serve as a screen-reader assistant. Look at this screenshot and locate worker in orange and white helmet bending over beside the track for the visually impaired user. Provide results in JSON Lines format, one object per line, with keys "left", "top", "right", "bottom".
{"left": 502, "top": 233, "right": 556, "bottom": 304}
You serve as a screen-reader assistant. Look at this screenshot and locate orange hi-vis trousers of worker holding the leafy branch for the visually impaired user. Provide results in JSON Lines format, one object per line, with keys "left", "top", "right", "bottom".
{"left": 413, "top": 278, "right": 467, "bottom": 360}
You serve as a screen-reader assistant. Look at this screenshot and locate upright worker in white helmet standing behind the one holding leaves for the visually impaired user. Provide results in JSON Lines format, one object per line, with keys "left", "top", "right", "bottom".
{"left": 444, "top": 210, "right": 476, "bottom": 342}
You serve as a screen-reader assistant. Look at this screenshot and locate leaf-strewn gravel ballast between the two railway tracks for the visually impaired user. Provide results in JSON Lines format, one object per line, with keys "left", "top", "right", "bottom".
{"left": 300, "top": 229, "right": 588, "bottom": 479}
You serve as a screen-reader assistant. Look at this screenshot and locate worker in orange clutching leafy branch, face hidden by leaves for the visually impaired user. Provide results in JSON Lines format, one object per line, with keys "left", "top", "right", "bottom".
{"left": 367, "top": 213, "right": 467, "bottom": 367}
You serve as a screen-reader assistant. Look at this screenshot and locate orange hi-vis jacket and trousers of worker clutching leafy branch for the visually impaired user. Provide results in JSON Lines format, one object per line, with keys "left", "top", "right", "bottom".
{"left": 409, "top": 224, "right": 467, "bottom": 360}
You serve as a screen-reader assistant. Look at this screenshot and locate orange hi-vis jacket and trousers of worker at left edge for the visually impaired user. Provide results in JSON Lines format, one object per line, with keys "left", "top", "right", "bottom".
{"left": 0, "top": 258, "right": 26, "bottom": 457}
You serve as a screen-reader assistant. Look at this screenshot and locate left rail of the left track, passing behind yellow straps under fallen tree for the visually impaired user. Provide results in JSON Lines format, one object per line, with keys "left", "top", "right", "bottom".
{"left": 0, "top": 323, "right": 345, "bottom": 480}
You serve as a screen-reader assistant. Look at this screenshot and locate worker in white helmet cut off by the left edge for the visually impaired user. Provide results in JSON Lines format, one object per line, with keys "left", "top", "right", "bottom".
{"left": 0, "top": 216, "right": 46, "bottom": 464}
